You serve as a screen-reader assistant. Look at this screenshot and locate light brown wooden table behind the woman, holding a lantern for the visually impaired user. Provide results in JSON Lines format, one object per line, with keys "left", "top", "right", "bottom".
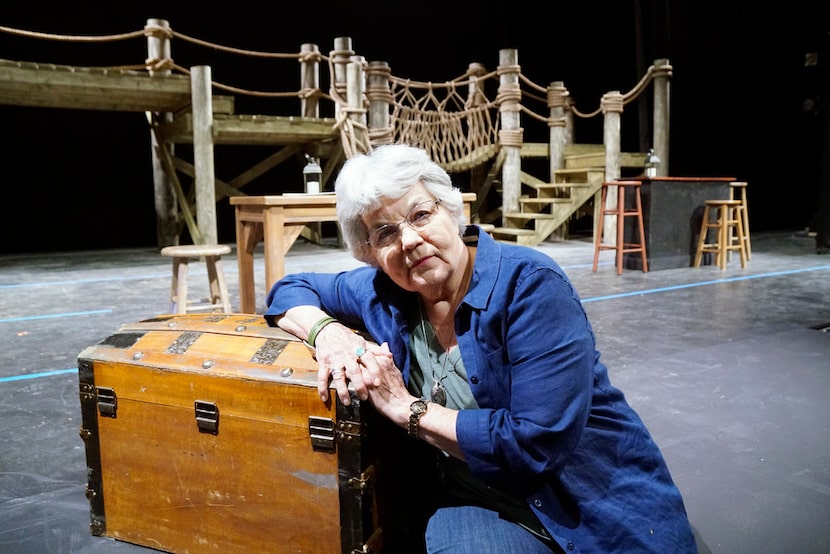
{"left": 230, "top": 193, "right": 476, "bottom": 314}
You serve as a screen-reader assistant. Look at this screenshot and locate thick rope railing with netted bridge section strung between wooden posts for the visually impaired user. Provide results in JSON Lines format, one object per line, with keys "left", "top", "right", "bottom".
{"left": 0, "top": 20, "right": 671, "bottom": 169}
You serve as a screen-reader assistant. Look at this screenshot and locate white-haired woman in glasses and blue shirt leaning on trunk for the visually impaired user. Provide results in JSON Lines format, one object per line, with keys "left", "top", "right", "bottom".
{"left": 265, "top": 145, "right": 696, "bottom": 554}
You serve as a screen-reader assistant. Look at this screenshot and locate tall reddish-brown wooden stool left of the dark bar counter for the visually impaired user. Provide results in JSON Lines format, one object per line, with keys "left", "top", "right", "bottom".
{"left": 594, "top": 181, "right": 648, "bottom": 275}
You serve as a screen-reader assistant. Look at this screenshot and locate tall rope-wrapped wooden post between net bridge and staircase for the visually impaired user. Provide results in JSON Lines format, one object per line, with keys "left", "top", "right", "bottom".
{"left": 498, "top": 49, "right": 522, "bottom": 213}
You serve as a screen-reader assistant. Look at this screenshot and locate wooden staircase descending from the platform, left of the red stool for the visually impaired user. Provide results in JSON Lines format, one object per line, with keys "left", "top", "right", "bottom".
{"left": 491, "top": 143, "right": 646, "bottom": 246}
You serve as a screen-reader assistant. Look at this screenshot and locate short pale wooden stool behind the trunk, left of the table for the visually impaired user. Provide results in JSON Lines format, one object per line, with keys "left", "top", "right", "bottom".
{"left": 161, "top": 244, "right": 231, "bottom": 314}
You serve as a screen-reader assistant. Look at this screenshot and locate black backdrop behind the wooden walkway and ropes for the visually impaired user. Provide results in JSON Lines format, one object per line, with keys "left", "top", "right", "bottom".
{"left": 0, "top": 0, "right": 830, "bottom": 253}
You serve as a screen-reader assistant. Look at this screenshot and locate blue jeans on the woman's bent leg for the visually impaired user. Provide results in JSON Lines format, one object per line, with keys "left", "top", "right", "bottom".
{"left": 426, "top": 506, "right": 556, "bottom": 554}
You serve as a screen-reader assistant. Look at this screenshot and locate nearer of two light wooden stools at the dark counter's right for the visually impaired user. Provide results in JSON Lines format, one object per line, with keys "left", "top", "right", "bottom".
{"left": 694, "top": 200, "right": 746, "bottom": 269}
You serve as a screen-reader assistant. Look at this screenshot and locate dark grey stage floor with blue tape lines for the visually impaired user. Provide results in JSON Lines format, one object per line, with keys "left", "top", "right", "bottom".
{"left": 0, "top": 233, "right": 830, "bottom": 554}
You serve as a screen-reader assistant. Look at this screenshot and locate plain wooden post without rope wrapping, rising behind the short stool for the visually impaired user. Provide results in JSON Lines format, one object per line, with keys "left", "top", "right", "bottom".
{"left": 190, "top": 65, "right": 214, "bottom": 244}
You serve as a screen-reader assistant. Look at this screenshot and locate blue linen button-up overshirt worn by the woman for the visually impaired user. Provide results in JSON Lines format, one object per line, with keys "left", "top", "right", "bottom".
{"left": 265, "top": 228, "right": 697, "bottom": 554}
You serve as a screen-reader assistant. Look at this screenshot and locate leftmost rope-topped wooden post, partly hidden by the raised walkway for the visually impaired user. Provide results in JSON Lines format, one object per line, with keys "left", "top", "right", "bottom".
{"left": 147, "top": 19, "right": 180, "bottom": 248}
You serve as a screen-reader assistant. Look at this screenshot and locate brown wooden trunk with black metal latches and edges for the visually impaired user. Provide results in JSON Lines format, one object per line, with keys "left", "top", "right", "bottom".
{"left": 78, "top": 314, "right": 398, "bottom": 554}
